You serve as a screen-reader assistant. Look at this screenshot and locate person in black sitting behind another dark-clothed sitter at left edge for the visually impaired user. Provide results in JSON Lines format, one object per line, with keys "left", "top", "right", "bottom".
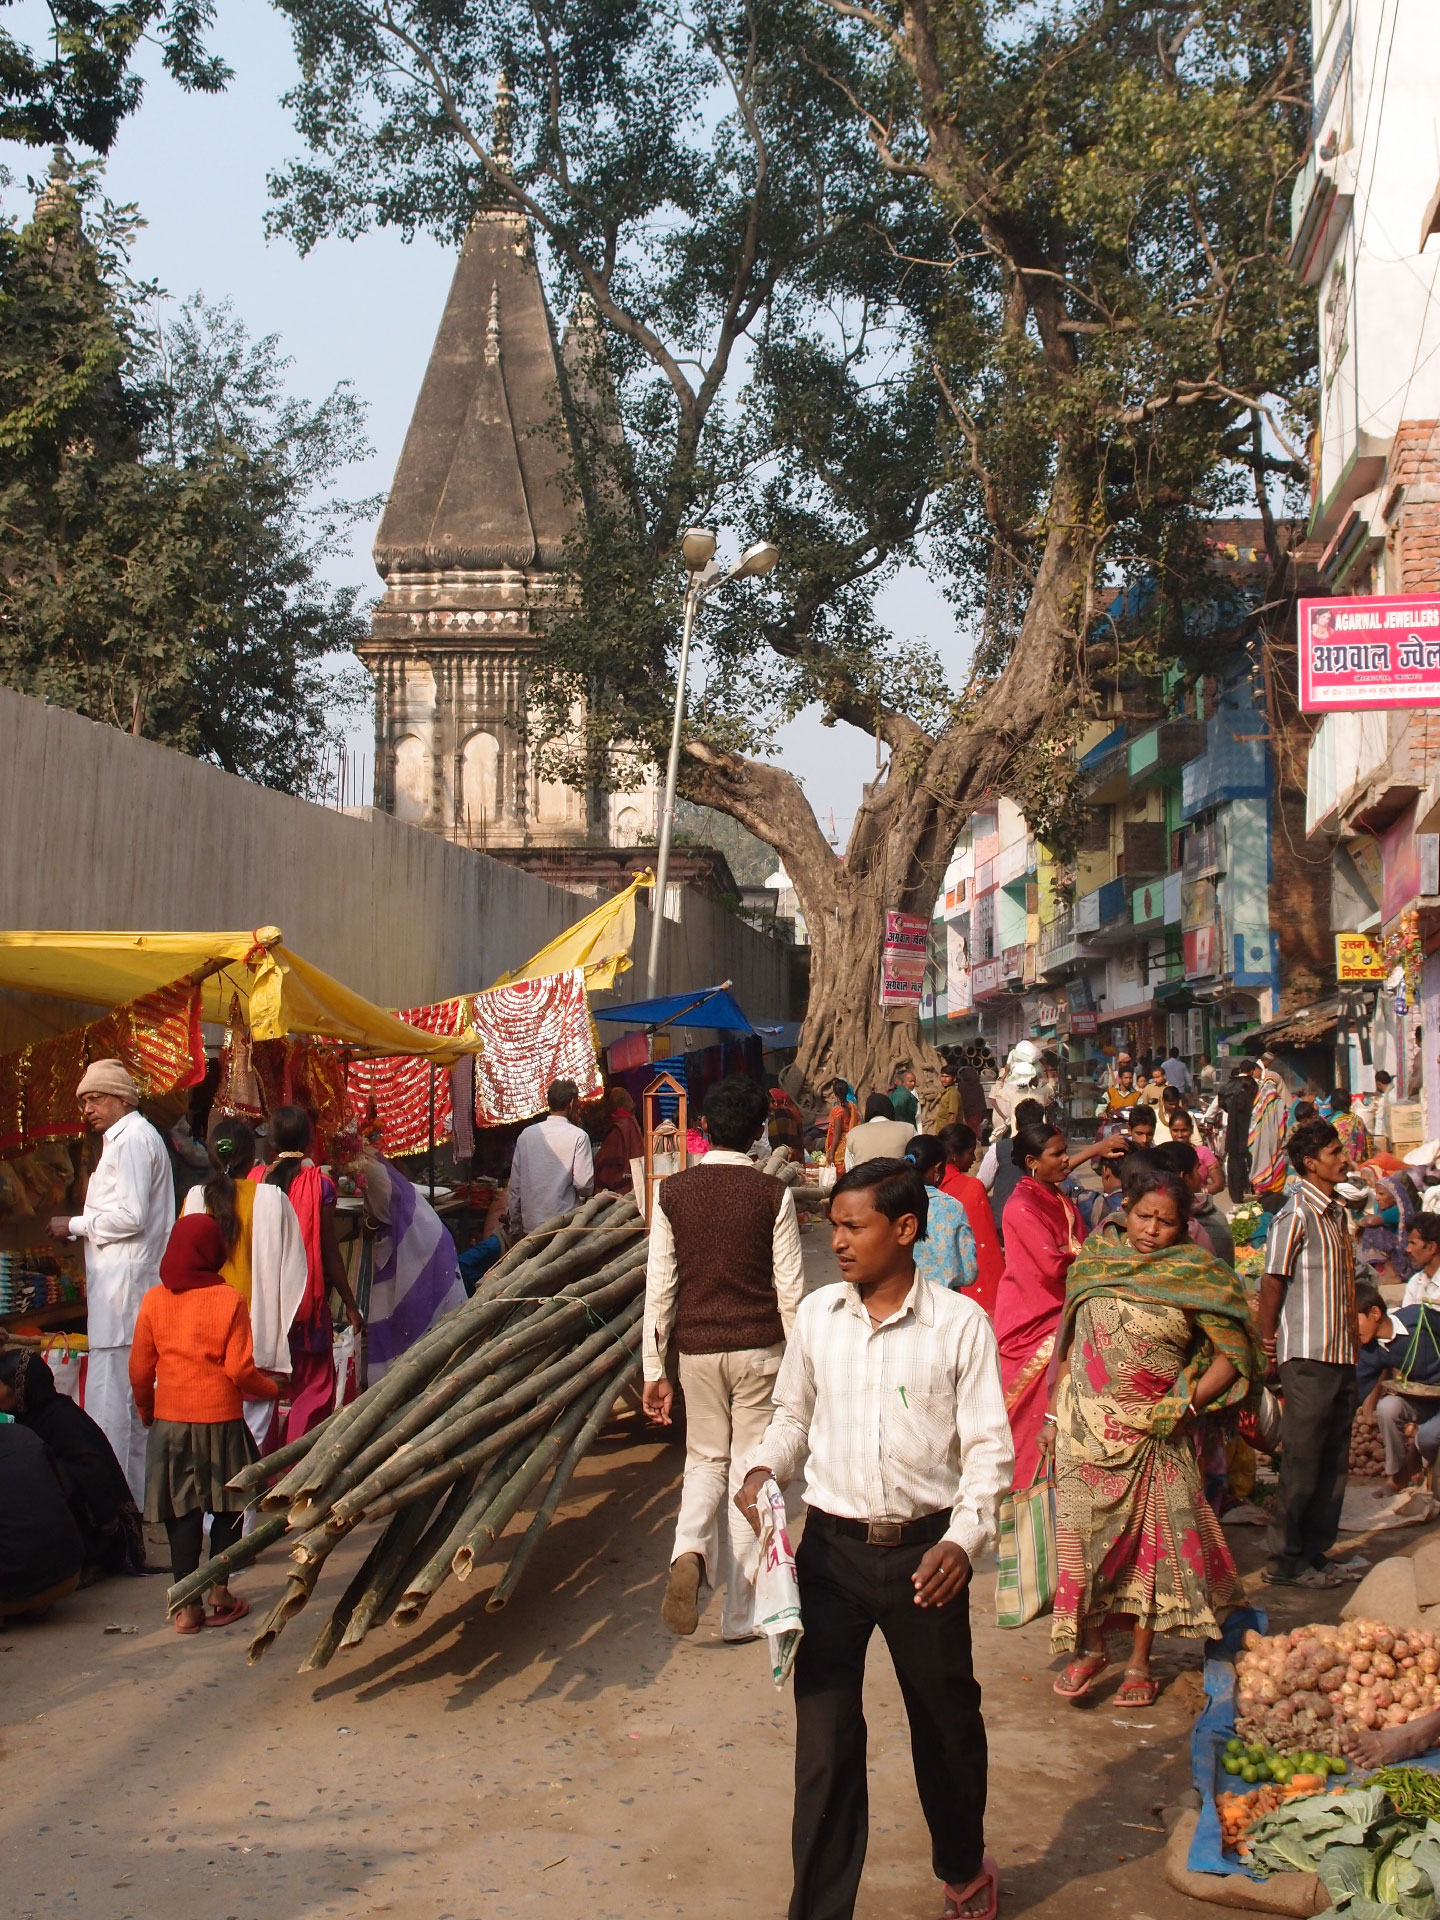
{"left": 0, "top": 1346, "right": 146, "bottom": 1584}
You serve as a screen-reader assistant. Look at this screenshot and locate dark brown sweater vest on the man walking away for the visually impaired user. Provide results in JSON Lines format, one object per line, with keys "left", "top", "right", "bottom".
{"left": 659, "top": 1165, "right": 785, "bottom": 1354}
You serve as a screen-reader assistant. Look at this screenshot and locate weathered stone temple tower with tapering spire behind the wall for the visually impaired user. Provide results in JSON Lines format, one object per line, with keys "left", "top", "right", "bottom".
{"left": 359, "top": 185, "right": 655, "bottom": 851}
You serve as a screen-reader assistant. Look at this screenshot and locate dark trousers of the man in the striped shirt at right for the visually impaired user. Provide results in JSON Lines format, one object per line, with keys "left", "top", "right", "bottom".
{"left": 1267, "top": 1359, "right": 1357, "bottom": 1578}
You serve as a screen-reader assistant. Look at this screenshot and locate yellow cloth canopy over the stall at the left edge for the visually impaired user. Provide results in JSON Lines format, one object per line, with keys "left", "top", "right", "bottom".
{"left": 0, "top": 927, "right": 478, "bottom": 1066}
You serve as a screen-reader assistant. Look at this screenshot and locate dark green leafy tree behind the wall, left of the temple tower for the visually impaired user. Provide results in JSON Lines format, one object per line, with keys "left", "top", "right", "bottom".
{"left": 0, "top": 175, "right": 374, "bottom": 791}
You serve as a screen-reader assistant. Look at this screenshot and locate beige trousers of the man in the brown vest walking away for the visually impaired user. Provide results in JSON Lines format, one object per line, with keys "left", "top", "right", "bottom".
{"left": 670, "top": 1346, "right": 785, "bottom": 1640}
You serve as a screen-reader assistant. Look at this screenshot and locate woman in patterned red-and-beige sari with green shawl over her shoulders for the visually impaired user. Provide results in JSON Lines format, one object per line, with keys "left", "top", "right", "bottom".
{"left": 1044, "top": 1164, "right": 1265, "bottom": 1707}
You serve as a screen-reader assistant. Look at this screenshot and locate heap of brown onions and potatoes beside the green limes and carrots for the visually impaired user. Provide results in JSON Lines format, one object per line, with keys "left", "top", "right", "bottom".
{"left": 1235, "top": 1620, "right": 1440, "bottom": 1755}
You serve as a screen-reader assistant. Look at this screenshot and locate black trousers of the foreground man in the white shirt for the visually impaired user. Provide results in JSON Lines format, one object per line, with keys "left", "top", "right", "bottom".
{"left": 789, "top": 1513, "right": 987, "bottom": 1920}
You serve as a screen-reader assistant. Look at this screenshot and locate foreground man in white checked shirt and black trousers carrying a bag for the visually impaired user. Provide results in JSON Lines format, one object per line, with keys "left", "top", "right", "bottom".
{"left": 735, "top": 1160, "right": 1014, "bottom": 1920}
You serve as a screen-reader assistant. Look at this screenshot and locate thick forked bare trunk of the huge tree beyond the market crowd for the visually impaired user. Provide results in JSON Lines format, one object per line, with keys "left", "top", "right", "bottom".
{"left": 685, "top": 467, "right": 1094, "bottom": 1096}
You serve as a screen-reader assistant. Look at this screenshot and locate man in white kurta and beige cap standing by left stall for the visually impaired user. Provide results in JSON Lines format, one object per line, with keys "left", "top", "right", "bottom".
{"left": 50, "top": 1060, "right": 175, "bottom": 1507}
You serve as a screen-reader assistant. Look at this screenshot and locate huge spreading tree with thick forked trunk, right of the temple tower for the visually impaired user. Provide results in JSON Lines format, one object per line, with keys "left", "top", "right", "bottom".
{"left": 275, "top": 0, "right": 1313, "bottom": 1083}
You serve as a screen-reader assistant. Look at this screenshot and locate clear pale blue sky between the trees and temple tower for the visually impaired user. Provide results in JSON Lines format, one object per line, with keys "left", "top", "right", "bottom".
{"left": 0, "top": 0, "right": 964, "bottom": 839}
